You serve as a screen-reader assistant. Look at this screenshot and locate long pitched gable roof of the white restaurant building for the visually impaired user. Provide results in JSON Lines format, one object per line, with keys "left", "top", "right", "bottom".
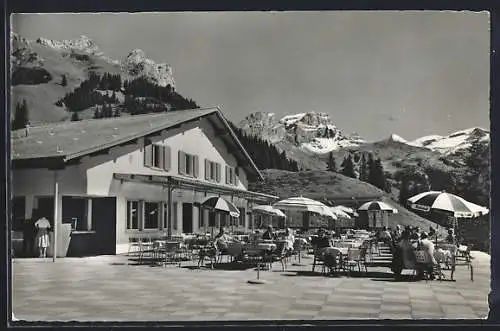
{"left": 11, "top": 108, "right": 262, "bottom": 179}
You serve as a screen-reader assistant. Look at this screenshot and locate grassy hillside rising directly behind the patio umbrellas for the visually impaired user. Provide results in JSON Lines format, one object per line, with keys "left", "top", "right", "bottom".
{"left": 250, "top": 170, "right": 448, "bottom": 237}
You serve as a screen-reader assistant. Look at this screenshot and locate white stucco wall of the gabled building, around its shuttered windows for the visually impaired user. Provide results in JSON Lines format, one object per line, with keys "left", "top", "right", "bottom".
{"left": 12, "top": 119, "right": 256, "bottom": 253}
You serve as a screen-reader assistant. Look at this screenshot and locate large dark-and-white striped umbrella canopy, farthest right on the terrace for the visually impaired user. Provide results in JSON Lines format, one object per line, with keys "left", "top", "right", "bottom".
{"left": 408, "top": 191, "right": 489, "bottom": 218}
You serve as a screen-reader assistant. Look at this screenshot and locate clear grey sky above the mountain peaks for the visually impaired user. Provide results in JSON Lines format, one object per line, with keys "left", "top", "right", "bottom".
{"left": 12, "top": 11, "right": 490, "bottom": 140}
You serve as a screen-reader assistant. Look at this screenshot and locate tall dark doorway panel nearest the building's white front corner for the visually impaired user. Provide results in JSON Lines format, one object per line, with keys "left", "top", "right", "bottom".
{"left": 92, "top": 197, "right": 116, "bottom": 255}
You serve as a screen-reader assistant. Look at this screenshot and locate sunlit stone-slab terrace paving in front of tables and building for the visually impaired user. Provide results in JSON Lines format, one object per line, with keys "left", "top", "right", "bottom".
{"left": 12, "top": 252, "right": 490, "bottom": 321}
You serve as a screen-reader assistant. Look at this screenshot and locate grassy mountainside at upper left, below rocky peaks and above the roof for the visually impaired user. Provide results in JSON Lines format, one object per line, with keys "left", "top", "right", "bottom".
{"left": 12, "top": 43, "right": 120, "bottom": 123}
